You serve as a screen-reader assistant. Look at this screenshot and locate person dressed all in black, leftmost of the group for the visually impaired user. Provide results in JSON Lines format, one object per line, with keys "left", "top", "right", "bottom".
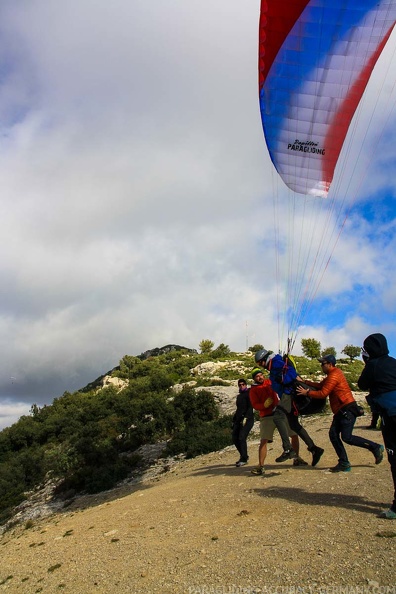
{"left": 232, "top": 378, "right": 254, "bottom": 466}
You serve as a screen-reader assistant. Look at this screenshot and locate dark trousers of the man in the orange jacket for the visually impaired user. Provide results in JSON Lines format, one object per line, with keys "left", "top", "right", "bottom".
{"left": 329, "top": 409, "right": 379, "bottom": 466}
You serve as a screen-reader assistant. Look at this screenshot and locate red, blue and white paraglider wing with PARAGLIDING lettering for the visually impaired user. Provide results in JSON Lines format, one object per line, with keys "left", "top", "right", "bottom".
{"left": 259, "top": 0, "right": 396, "bottom": 197}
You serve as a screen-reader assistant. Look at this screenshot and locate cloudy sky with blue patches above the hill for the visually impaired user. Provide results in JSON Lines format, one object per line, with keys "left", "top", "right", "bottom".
{"left": 0, "top": 0, "right": 396, "bottom": 428}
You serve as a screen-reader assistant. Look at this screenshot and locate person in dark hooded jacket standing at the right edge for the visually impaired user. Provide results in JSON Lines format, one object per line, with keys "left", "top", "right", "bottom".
{"left": 358, "top": 333, "right": 396, "bottom": 520}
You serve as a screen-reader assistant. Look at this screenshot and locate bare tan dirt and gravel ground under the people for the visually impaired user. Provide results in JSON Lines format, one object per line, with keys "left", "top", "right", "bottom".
{"left": 0, "top": 415, "right": 396, "bottom": 594}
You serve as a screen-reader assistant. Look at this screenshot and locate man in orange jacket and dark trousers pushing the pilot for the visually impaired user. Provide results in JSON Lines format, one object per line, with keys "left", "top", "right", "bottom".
{"left": 297, "top": 355, "right": 384, "bottom": 472}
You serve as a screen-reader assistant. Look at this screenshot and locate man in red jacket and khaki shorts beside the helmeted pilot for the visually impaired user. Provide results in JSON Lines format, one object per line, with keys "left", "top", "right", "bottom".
{"left": 249, "top": 369, "right": 308, "bottom": 475}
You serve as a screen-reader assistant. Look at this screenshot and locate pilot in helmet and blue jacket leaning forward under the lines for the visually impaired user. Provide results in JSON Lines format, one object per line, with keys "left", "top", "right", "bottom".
{"left": 254, "top": 349, "right": 324, "bottom": 466}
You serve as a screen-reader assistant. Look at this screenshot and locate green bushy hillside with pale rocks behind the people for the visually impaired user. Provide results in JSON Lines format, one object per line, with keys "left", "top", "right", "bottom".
{"left": 0, "top": 344, "right": 362, "bottom": 531}
